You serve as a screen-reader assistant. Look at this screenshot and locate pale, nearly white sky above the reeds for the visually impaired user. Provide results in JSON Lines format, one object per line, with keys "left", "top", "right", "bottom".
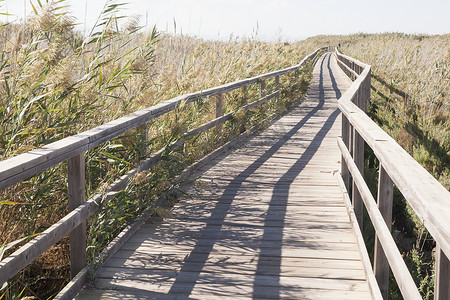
{"left": 0, "top": 0, "right": 450, "bottom": 41}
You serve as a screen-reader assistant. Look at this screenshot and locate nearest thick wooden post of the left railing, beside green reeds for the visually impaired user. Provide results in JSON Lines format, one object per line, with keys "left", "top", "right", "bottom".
{"left": 67, "top": 152, "right": 86, "bottom": 278}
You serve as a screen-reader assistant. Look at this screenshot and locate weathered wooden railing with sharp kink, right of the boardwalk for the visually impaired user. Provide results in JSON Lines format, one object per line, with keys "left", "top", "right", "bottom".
{"left": 336, "top": 49, "right": 450, "bottom": 300}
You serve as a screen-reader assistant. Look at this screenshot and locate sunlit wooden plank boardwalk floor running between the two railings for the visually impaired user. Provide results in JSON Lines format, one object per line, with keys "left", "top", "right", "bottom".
{"left": 78, "top": 54, "right": 371, "bottom": 300}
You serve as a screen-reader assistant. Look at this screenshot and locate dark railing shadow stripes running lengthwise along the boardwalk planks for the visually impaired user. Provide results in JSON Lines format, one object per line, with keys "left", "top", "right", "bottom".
{"left": 105, "top": 55, "right": 341, "bottom": 298}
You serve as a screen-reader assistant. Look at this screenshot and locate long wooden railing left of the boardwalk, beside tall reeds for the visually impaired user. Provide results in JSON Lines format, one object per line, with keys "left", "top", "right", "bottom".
{"left": 0, "top": 48, "right": 325, "bottom": 294}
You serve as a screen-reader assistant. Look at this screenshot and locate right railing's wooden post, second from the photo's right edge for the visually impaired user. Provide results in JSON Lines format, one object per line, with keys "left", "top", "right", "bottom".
{"left": 373, "top": 165, "right": 394, "bottom": 299}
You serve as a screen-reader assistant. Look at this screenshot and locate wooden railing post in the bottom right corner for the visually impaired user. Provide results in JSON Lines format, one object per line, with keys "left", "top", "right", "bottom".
{"left": 434, "top": 245, "right": 450, "bottom": 300}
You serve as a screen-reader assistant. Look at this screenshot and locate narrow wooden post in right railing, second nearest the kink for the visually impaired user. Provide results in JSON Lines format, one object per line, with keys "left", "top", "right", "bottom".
{"left": 352, "top": 128, "right": 364, "bottom": 230}
